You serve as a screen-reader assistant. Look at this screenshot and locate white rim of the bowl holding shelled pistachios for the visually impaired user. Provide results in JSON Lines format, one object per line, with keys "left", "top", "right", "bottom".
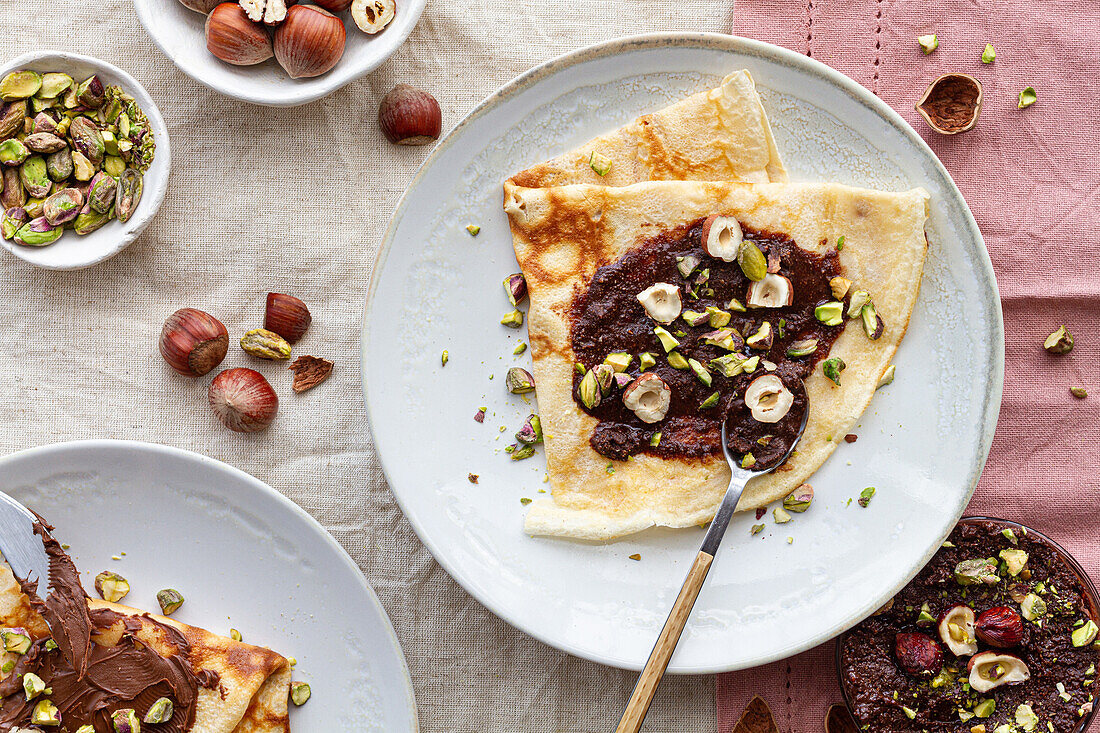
{"left": 0, "top": 48, "right": 172, "bottom": 270}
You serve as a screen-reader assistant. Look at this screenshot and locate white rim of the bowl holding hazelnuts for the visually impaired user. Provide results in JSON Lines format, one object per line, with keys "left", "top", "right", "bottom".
{"left": 133, "top": 0, "right": 428, "bottom": 107}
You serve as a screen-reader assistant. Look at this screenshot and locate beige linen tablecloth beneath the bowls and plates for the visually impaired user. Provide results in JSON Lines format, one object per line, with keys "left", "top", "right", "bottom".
{"left": 0, "top": 0, "right": 733, "bottom": 733}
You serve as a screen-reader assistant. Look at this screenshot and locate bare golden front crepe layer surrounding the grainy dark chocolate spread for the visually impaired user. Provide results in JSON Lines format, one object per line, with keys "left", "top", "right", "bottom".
{"left": 505, "top": 182, "right": 928, "bottom": 540}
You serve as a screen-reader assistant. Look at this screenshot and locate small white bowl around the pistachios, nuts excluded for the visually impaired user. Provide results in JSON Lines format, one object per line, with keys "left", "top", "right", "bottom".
{"left": 0, "top": 51, "right": 172, "bottom": 270}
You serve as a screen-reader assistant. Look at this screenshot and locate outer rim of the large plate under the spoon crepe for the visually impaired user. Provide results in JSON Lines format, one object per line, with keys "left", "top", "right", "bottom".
{"left": 360, "top": 33, "right": 1004, "bottom": 675}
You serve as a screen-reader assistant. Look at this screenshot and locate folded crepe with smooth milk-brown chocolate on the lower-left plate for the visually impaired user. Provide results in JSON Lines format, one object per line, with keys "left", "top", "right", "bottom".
{"left": 0, "top": 550, "right": 292, "bottom": 733}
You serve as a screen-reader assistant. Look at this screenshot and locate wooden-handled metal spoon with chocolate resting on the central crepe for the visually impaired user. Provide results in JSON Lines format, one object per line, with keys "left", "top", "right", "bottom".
{"left": 616, "top": 385, "right": 810, "bottom": 733}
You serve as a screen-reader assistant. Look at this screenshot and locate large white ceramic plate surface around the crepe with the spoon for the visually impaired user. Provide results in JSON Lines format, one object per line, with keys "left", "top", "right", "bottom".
{"left": 363, "top": 35, "right": 1004, "bottom": 672}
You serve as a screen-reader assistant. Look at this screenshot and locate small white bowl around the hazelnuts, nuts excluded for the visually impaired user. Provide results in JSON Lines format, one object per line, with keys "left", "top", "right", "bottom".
{"left": 134, "top": 0, "right": 426, "bottom": 107}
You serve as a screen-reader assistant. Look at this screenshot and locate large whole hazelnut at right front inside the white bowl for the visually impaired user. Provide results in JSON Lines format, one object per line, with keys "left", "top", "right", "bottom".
{"left": 275, "top": 6, "right": 347, "bottom": 79}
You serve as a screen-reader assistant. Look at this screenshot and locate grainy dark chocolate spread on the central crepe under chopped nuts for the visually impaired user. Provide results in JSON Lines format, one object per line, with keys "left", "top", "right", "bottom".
{"left": 572, "top": 220, "right": 843, "bottom": 466}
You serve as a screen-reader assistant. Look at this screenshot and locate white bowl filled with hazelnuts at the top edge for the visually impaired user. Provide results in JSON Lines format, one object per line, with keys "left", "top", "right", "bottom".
{"left": 134, "top": 0, "right": 426, "bottom": 107}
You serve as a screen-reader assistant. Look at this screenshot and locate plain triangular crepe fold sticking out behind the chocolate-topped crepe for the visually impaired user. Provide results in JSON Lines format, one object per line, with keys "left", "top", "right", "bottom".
{"left": 509, "top": 69, "right": 787, "bottom": 188}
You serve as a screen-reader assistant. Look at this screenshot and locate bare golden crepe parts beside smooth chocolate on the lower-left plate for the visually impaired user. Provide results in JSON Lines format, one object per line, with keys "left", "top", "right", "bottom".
{"left": 0, "top": 562, "right": 292, "bottom": 733}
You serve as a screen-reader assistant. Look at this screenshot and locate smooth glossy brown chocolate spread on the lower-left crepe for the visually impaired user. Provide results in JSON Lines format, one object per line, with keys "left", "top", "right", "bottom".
{"left": 0, "top": 519, "right": 219, "bottom": 733}
